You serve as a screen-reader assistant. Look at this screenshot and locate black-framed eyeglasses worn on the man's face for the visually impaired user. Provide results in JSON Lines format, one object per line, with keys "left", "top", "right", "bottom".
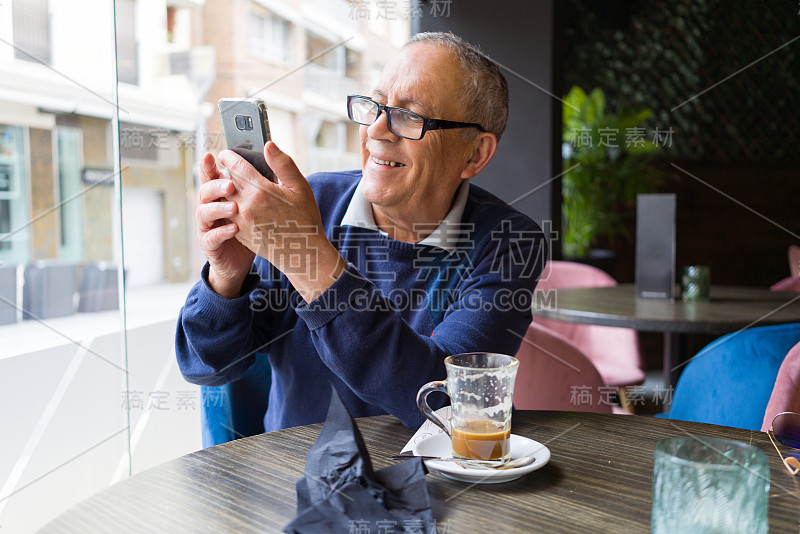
{"left": 347, "top": 95, "right": 486, "bottom": 141}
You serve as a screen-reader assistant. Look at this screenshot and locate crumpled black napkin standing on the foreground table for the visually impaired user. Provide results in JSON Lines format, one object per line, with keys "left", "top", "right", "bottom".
{"left": 283, "top": 388, "right": 436, "bottom": 534}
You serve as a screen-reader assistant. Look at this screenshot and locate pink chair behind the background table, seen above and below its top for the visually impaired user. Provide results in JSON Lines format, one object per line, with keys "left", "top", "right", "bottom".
{"left": 534, "top": 261, "right": 645, "bottom": 387}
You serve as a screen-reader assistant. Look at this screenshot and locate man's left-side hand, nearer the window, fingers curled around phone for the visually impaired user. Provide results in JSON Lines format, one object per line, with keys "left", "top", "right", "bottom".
{"left": 195, "top": 154, "right": 255, "bottom": 298}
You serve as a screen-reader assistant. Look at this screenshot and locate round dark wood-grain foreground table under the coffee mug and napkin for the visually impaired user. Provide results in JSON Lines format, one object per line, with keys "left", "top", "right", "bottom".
{"left": 42, "top": 411, "right": 800, "bottom": 534}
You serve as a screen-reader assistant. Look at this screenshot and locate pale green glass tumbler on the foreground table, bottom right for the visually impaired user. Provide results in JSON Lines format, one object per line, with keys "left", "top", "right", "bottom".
{"left": 650, "top": 437, "right": 769, "bottom": 534}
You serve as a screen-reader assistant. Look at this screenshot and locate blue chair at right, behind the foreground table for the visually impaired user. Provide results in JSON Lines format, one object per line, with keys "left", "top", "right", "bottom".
{"left": 663, "top": 324, "right": 800, "bottom": 430}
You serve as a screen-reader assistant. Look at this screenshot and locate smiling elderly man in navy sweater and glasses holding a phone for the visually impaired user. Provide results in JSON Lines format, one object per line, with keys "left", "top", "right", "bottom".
{"left": 176, "top": 34, "right": 546, "bottom": 431}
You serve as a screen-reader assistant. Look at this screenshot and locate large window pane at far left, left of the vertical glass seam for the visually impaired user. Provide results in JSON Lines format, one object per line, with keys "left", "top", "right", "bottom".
{"left": 0, "top": 0, "right": 131, "bottom": 532}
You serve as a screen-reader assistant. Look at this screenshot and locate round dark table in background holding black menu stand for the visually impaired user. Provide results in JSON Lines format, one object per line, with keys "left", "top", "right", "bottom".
{"left": 533, "top": 284, "right": 800, "bottom": 387}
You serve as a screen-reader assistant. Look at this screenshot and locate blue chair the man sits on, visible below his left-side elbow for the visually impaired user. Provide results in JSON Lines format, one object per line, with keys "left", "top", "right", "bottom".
{"left": 200, "top": 353, "right": 272, "bottom": 448}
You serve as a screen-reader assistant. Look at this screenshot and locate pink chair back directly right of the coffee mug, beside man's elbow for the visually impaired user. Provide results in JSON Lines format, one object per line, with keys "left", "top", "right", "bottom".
{"left": 514, "top": 323, "right": 627, "bottom": 414}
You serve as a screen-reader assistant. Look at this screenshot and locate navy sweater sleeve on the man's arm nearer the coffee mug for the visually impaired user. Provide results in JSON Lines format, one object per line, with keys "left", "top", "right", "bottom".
{"left": 297, "top": 216, "right": 546, "bottom": 428}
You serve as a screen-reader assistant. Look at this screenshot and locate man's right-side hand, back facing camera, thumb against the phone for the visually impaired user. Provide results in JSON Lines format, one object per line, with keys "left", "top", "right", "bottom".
{"left": 219, "top": 141, "right": 346, "bottom": 302}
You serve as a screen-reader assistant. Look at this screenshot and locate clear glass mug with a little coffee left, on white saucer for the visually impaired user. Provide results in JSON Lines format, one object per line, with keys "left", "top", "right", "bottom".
{"left": 417, "top": 352, "right": 519, "bottom": 462}
